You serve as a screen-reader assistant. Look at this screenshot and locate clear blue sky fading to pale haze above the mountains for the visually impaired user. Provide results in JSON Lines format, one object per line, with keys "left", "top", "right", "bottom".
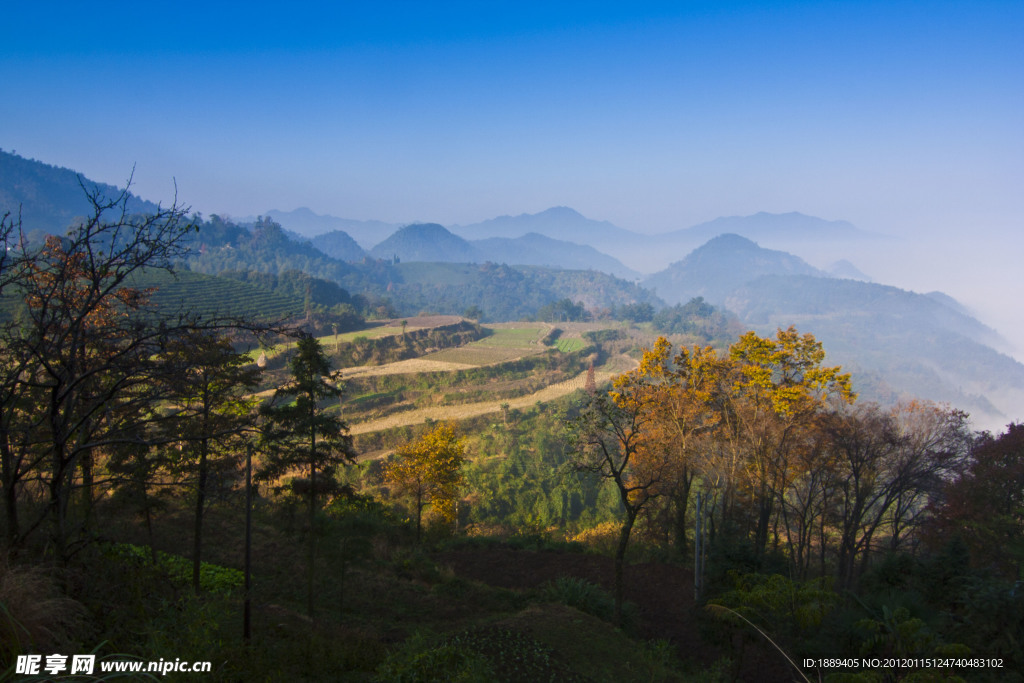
{"left": 0, "top": 0, "right": 1024, "bottom": 352}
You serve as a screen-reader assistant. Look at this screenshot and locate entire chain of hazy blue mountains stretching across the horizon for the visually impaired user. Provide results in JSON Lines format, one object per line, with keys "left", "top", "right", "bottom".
{"left": 0, "top": 152, "right": 1024, "bottom": 425}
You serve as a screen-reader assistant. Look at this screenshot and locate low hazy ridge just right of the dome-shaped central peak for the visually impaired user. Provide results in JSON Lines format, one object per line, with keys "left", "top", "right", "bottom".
{"left": 470, "top": 232, "right": 640, "bottom": 280}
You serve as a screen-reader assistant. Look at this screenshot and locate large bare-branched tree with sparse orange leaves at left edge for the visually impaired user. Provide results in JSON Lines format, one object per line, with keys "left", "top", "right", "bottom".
{"left": 0, "top": 183, "right": 210, "bottom": 561}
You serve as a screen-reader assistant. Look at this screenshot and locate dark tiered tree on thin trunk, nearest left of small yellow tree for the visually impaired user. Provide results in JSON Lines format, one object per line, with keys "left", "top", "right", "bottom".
{"left": 258, "top": 334, "right": 355, "bottom": 617}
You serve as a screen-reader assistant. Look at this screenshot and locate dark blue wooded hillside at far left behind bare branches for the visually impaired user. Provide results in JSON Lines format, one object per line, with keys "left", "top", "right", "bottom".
{"left": 0, "top": 150, "right": 159, "bottom": 233}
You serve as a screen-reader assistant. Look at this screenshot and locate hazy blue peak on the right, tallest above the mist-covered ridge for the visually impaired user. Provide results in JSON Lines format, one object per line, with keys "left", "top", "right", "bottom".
{"left": 643, "top": 234, "right": 825, "bottom": 304}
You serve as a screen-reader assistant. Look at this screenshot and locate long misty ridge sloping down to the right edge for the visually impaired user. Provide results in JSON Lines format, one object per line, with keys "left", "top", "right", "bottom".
{"left": 725, "top": 275, "right": 1024, "bottom": 420}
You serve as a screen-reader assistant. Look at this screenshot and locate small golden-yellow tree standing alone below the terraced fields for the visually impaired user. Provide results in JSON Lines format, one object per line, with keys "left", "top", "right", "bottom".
{"left": 384, "top": 423, "right": 466, "bottom": 543}
